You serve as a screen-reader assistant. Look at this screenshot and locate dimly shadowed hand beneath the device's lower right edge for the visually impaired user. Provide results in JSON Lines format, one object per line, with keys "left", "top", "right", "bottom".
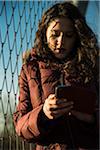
{"left": 71, "top": 110, "right": 94, "bottom": 123}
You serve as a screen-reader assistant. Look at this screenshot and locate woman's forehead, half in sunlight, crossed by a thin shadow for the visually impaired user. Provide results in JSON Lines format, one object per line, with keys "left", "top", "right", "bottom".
{"left": 48, "top": 18, "right": 74, "bottom": 31}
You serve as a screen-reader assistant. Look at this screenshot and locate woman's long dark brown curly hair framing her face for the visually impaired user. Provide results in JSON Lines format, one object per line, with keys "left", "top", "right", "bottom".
{"left": 34, "top": 2, "right": 98, "bottom": 82}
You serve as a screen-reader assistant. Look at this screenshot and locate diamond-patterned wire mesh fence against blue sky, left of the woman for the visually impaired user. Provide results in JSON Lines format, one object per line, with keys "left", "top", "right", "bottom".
{"left": 0, "top": 0, "right": 99, "bottom": 150}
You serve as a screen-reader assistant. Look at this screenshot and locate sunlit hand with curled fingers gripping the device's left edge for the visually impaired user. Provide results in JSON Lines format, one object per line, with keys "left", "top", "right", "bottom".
{"left": 43, "top": 94, "right": 73, "bottom": 119}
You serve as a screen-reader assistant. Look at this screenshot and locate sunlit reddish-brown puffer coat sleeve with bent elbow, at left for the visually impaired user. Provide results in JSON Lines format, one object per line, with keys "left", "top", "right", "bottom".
{"left": 13, "top": 63, "right": 61, "bottom": 143}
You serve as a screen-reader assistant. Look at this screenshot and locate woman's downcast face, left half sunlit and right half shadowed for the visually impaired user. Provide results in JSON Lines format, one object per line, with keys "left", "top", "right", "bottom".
{"left": 46, "top": 18, "right": 77, "bottom": 59}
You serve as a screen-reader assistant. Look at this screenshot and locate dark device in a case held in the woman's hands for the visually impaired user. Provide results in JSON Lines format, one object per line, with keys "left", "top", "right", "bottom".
{"left": 55, "top": 85, "right": 96, "bottom": 114}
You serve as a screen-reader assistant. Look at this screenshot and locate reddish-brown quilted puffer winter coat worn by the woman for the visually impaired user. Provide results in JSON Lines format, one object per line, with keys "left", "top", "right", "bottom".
{"left": 14, "top": 49, "right": 98, "bottom": 150}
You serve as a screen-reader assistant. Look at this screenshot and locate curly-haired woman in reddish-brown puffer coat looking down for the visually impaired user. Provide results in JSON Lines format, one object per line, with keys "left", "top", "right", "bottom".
{"left": 14, "top": 2, "right": 98, "bottom": 150}
